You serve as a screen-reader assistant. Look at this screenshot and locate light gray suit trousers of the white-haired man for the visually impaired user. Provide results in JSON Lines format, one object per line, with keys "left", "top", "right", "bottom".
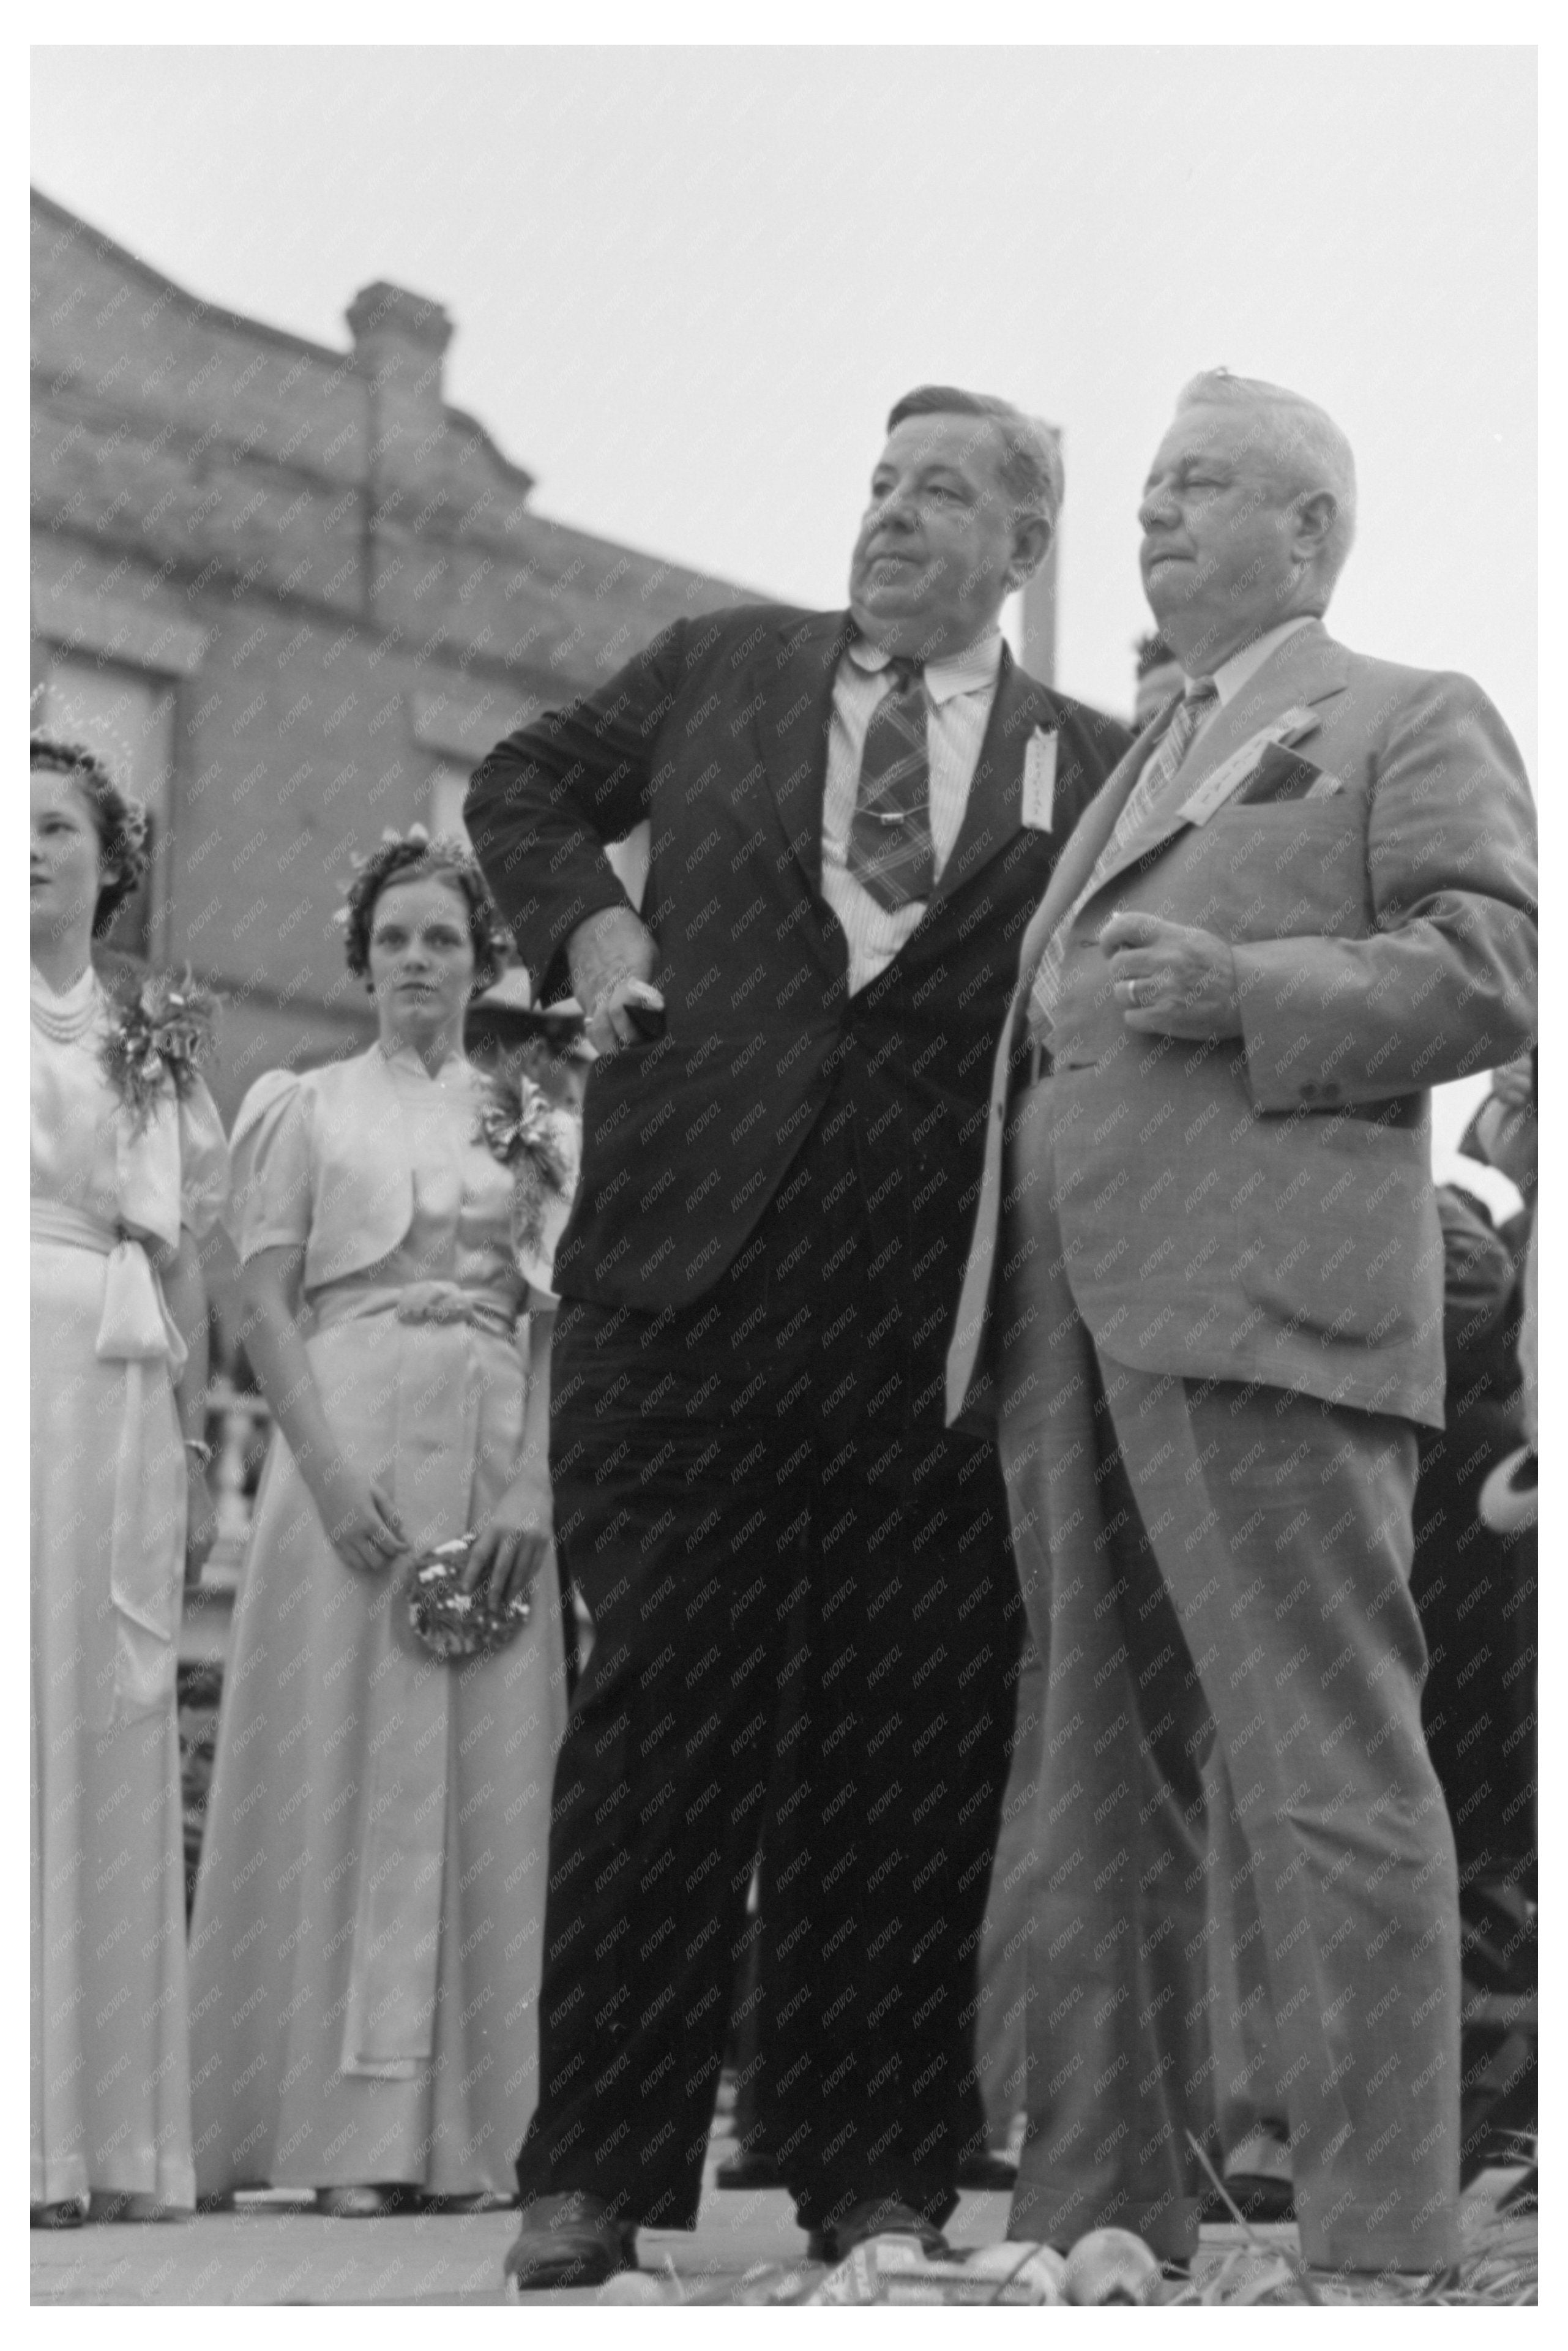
{"left": 999, "top": 1079, "right": 1460, "bottom": 2269}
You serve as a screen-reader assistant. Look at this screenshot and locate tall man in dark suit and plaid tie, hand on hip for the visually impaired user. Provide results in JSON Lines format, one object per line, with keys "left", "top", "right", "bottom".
{"left": 468, "top": 388, "right": 1126, "bottom": 2285}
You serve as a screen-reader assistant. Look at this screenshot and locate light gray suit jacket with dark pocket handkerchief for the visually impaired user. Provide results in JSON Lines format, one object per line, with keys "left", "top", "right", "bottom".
{"left": 947, "top": 623, "right": 1535, "bottom": 1427}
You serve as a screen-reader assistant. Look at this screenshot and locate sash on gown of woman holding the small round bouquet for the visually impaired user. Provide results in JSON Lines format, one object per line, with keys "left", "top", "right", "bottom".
{"left": 313, "top": 1281, "right": 517, "bottom": 2080}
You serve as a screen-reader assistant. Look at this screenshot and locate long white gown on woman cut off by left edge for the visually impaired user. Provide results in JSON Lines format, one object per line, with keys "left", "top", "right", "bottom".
{"left": 31, "top": 954, "right": 228, "bottom": 2208}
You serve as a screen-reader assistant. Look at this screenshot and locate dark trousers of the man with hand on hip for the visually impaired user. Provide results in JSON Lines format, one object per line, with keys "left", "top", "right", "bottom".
{"left": 517, "top": 1081, "right": 1023, "bottom": 2229}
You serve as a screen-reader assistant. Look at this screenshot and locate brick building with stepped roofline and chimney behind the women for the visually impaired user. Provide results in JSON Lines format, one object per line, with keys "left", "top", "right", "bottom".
{"left": 33, "top": 193, "right": 743, "bottom": 1116}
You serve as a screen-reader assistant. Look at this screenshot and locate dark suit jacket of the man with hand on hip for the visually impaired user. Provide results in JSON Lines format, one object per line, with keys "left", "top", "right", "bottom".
{"left": 466, "top": 604, "right": 1129, "bottom": 1307}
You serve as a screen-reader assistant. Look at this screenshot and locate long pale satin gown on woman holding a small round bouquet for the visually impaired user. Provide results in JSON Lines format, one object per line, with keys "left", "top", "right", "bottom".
{"left": 190, "top": 1046, "right": 567, "bottom": 2196}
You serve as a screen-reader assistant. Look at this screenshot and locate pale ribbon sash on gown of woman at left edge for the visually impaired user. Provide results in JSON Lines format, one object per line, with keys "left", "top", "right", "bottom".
{"left": 28, "top": 1199, "right": 185, "bottom": 1733}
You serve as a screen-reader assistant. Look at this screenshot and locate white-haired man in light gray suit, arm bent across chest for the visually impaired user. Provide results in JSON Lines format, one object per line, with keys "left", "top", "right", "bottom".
{"left": 950, "top": 372, "right": 1535, "bottom": 2271}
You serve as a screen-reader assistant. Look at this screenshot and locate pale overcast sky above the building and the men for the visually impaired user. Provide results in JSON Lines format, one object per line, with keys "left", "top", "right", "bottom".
{"left": 33, "top": 47, "right": 1535, "bottom": 764}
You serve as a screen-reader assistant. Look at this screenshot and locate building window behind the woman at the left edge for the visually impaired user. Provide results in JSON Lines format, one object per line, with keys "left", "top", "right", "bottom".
{"left": 40, "top": 654, "right": 174, "bottom": 962}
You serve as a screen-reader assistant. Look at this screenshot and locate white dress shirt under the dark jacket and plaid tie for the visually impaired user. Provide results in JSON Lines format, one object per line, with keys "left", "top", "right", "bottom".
{"left": 823, "top": 630, "right": 1001, "bottom": 997}
